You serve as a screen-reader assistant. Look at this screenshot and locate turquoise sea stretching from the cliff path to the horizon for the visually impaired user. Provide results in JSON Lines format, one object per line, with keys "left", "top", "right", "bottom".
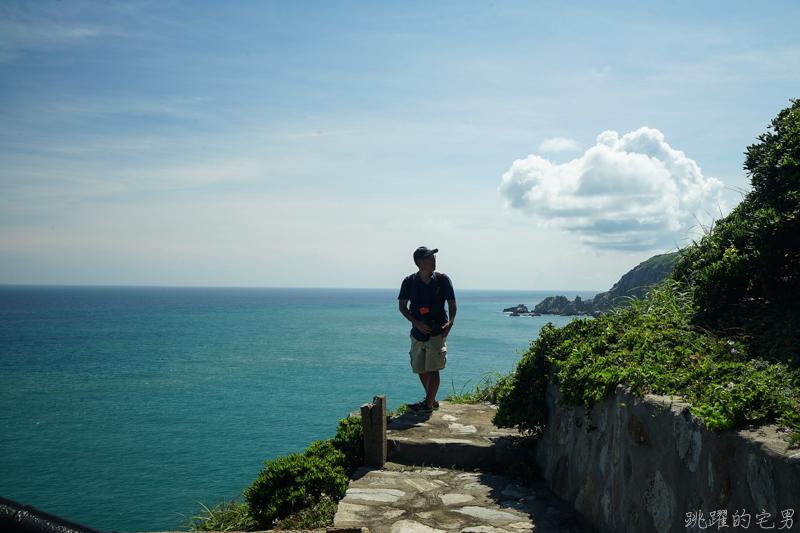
{"left": 0, "top": 286, "right": 595, "bottom": 532}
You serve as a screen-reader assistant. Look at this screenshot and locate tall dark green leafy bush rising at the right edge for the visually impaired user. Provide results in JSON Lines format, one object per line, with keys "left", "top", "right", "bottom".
{"left": 674, "top": 100, "right": 800, "bottom": 365}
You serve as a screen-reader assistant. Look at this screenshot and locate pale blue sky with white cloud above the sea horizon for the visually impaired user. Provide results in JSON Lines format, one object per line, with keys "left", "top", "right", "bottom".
{"left": 0, "top": 0, "right": 800, "bottom": 291}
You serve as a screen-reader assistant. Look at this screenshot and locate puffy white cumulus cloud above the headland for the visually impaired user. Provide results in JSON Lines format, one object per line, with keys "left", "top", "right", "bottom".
{"left": 499, "top": 128, "right": 723, "bottom": 251}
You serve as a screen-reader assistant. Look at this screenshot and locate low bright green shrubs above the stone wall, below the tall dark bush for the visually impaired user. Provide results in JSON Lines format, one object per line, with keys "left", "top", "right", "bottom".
{"left": 494, "top": 281, "right": 800, "bottom": 434}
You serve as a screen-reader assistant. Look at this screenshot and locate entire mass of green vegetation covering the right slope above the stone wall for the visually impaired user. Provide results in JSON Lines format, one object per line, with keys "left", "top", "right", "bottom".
{"left": 495, "top": 101, "right": 800, "bottom": 443}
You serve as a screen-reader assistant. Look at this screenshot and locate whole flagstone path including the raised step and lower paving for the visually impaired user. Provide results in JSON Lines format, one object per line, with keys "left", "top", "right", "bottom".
{"left": 334, "top": 402, "right": 588, "bottom": 533}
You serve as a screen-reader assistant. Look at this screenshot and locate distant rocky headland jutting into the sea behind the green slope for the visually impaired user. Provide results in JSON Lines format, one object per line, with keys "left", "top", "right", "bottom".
{"left": 503, "top": 252, "right": 678, "bottom": 316}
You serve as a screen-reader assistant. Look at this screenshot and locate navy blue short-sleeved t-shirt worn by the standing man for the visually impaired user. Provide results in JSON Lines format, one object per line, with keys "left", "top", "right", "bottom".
{"left": 397, "top": 272, "right": 456, "bottom": 342}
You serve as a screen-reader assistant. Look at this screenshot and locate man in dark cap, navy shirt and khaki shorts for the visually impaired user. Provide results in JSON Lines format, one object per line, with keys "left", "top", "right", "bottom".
{"left": 397, "top": 246, "right": 456, "bottom": 415}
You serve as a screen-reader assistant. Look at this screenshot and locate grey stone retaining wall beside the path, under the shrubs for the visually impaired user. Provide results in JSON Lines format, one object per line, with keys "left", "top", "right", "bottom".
{"left": 536, "top": 386, "right": 800, "bottom": 533}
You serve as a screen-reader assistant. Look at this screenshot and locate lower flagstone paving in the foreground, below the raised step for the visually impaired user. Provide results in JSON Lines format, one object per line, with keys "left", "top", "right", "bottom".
{"left": 334, "top": 464, "right": 586, "bottom": 533}
